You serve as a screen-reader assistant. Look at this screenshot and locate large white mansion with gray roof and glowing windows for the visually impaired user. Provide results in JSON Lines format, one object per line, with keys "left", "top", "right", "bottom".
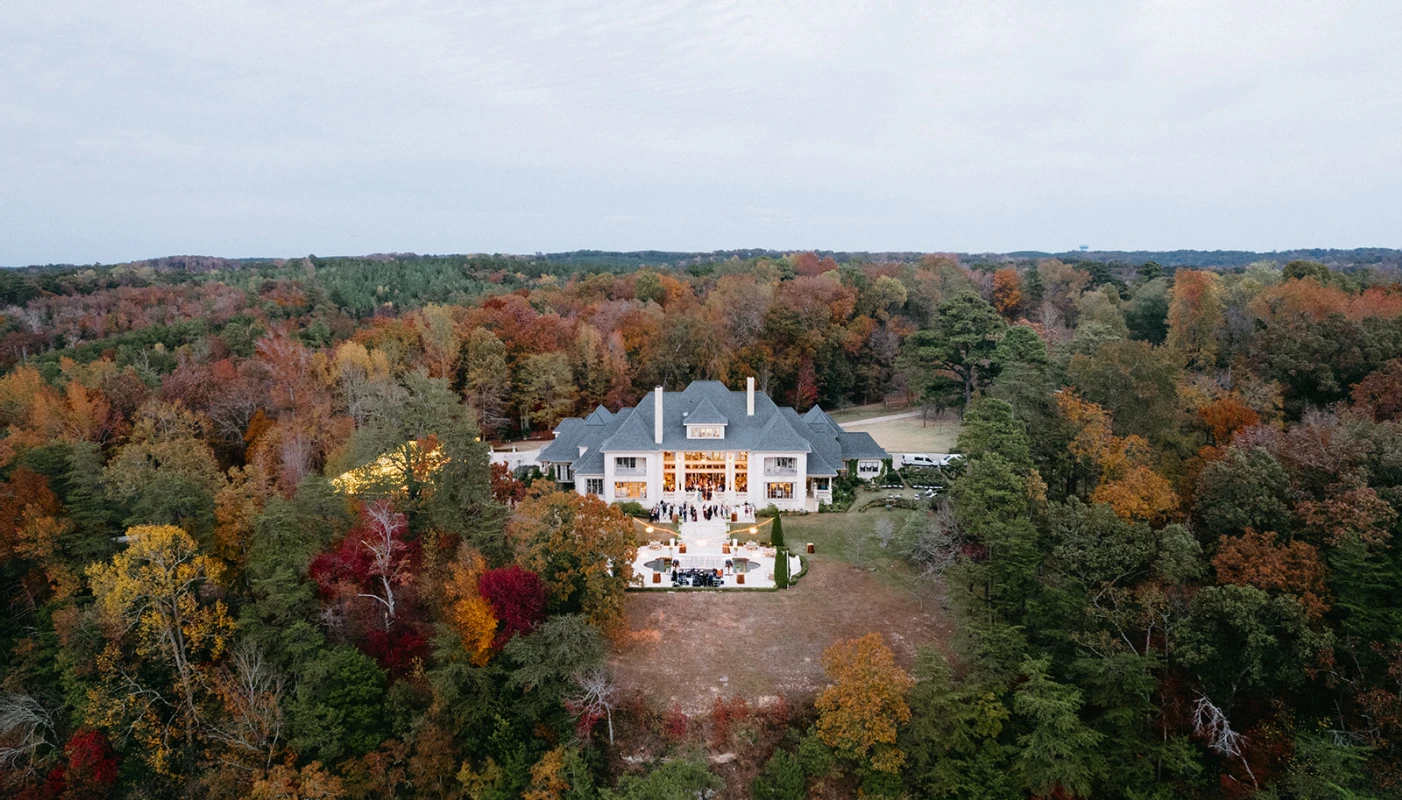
{"left": 538, "top": 378, "right": 890, "bottom": 511}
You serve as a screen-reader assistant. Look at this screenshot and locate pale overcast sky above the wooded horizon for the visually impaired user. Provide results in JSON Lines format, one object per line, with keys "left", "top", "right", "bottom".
{"left": 0, "top": 0, "right": 1402, "bottom": 265}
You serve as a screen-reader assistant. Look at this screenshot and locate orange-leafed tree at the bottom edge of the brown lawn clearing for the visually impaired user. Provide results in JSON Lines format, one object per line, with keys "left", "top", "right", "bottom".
{"left": 817, "top": 633, "right": 914, "bottom": 772}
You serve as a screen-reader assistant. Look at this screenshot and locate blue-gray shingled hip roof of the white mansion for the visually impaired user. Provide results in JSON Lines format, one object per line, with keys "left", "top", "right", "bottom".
{"left": 540, "top": 381, "right": 889, "bottom": 476}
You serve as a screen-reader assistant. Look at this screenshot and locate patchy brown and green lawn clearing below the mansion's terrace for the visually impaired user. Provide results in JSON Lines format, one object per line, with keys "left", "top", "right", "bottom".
{"left": 611, "top": 510, "right": 952, "bottom": 715}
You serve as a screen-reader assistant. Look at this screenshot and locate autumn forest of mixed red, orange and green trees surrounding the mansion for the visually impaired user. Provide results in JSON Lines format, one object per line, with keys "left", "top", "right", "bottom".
{"left": 0, "top": 251, "right": 1402, "bottom": 800}
